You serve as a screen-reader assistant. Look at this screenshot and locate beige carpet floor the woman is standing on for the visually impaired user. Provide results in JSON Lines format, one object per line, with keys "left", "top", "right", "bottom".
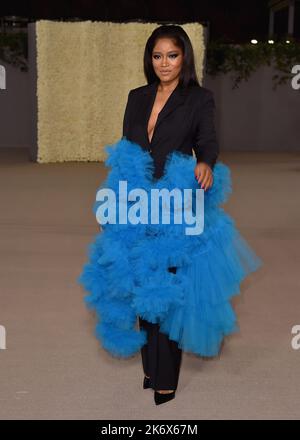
{"left": 0, "top": 149, "right": 300, "bottom": 420}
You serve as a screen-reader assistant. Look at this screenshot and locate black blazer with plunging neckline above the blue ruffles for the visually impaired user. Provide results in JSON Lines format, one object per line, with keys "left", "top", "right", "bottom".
{"left": 123, "top": 81, "right": 219, "bottom": 178}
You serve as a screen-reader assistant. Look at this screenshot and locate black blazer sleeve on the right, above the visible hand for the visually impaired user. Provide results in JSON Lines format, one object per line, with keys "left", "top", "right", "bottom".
{"left": 194, "top": 90, "right": 219, "bottom": 169}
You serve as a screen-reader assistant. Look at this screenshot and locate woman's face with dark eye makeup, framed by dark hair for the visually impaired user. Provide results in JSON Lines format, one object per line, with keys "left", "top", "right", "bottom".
{"left": 152, "top": 38, "right": 183, "bottom": 83}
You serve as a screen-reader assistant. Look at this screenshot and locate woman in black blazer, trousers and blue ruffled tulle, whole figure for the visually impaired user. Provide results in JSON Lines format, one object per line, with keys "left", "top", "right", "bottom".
{"left": 78, "top": 25, "right": 262, "bottom": 405}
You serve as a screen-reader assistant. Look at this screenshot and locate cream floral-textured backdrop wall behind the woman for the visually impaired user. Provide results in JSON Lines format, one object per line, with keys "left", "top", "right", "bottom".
{"left": 36, "top": 20, "right": 205, "bottom": 162}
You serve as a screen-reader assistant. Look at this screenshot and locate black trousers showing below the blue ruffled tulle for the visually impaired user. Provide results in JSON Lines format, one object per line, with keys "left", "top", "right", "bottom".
{"left": 139, "top": 267, "right": 182, "bottom": 390}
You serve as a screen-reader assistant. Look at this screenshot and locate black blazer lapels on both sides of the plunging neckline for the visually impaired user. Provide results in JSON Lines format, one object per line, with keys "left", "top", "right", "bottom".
{"left": 142, "top": 82, "right": 187, "bottom": 146}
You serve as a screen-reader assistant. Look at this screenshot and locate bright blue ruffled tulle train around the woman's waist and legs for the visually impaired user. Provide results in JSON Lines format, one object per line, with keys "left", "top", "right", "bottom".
{"left": 77, "top": 138, "right": 262, "bottom": 358}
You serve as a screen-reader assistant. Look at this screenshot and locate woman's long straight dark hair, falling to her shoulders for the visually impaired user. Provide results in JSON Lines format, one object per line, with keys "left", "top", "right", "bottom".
{"left": 144, "top": 24, "right": 200, "bottom": 87}
